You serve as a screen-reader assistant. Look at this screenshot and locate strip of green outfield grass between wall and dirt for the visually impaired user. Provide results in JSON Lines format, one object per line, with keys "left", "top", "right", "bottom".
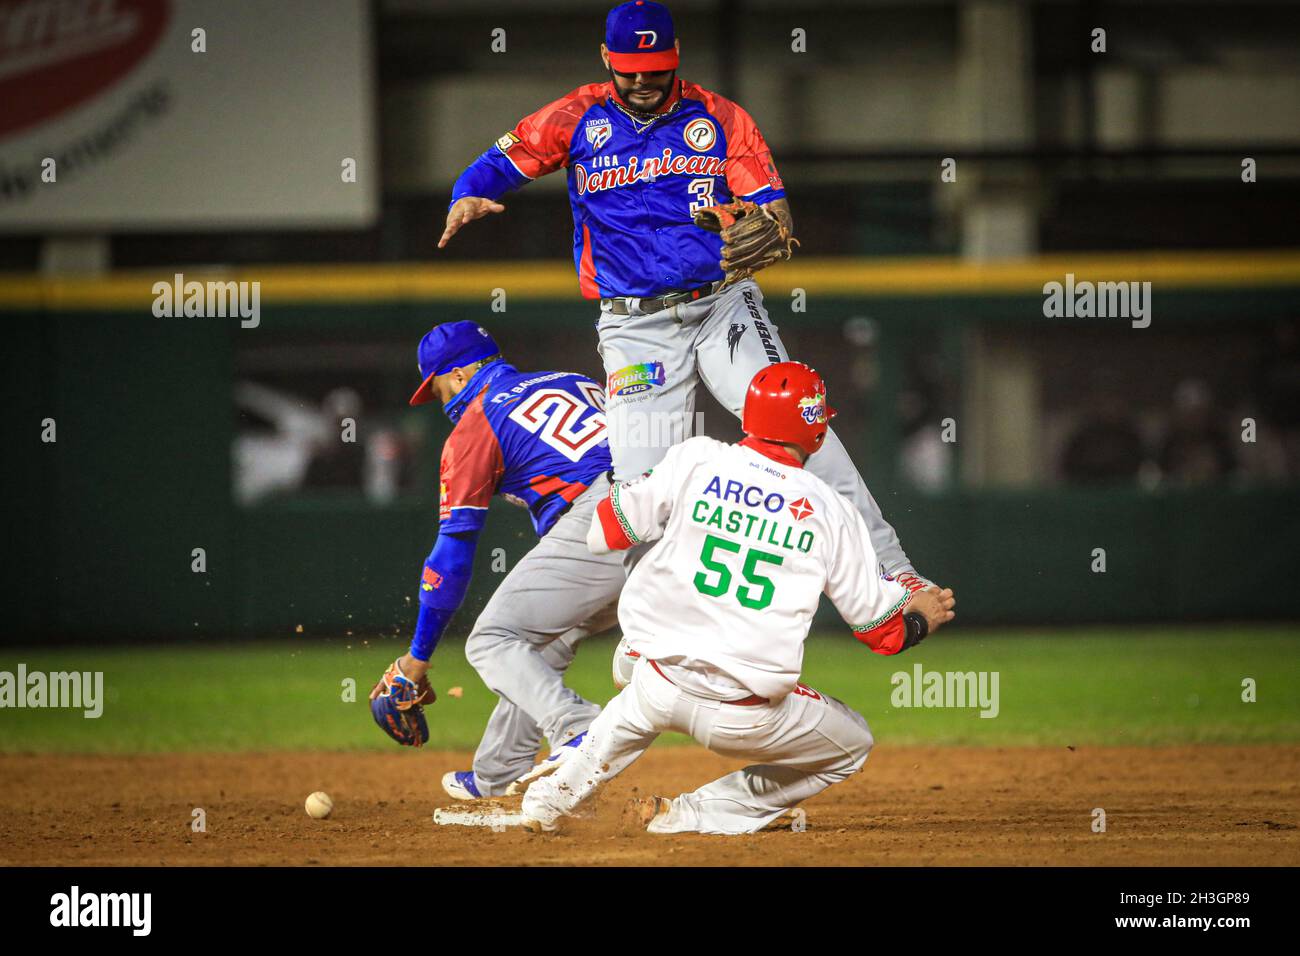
{"left": 0, "top": 626, "right": 1300, "bottom": 753}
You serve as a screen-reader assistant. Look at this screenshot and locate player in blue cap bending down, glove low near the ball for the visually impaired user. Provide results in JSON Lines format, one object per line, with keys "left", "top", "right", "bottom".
{"left": 371, "top": 321, "right": 625, "bottom": 800}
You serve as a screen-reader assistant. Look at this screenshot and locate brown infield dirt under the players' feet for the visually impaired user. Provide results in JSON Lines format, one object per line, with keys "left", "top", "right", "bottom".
{"left": 0, "top": 745, "right": 1300, "bottom": 866}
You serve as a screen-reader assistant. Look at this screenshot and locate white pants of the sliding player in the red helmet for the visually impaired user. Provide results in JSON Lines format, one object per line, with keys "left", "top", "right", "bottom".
{"left": 524, "top": 661, "right": 872, "bottom": 834}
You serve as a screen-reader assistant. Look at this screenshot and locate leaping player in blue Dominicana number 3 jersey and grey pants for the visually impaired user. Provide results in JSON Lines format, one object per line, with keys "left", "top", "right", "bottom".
{"left": 438, "top": 0, "right": 930, "bottom": 598}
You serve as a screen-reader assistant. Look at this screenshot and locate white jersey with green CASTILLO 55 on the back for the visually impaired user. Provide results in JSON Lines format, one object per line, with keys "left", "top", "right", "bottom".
{"left": 588, "top": 437, "right": 909, "bottom": 700}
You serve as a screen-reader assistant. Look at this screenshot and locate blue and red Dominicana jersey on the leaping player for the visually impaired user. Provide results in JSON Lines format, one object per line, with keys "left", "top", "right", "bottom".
{"left": 452, "top": 79, "right": 785, "bottom": 299}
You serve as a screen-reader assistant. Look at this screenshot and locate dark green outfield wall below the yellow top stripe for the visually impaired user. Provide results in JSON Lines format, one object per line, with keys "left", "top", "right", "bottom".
{"left": 0, "top": 254, "right": 1300, "bottom": 643}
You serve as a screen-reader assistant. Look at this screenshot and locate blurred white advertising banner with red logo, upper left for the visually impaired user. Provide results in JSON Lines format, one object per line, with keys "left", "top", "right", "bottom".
{"left": 0, "top": 0, "right": 380, "bottom": 234}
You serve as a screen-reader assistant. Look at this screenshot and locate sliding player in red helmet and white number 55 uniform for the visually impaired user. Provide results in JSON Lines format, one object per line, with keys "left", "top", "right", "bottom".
{"left": 523, "top": 362, "right": 954, "bottom": 834}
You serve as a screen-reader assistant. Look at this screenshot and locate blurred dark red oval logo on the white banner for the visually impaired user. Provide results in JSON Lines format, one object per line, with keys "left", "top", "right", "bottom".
{"left": 0, "top": 0, "right": 170, "bottom": 138}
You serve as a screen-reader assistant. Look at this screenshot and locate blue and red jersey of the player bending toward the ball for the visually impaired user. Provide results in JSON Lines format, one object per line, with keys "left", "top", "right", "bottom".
{"left": 438, "top": 362, "right": 611, "bottom": 536}
